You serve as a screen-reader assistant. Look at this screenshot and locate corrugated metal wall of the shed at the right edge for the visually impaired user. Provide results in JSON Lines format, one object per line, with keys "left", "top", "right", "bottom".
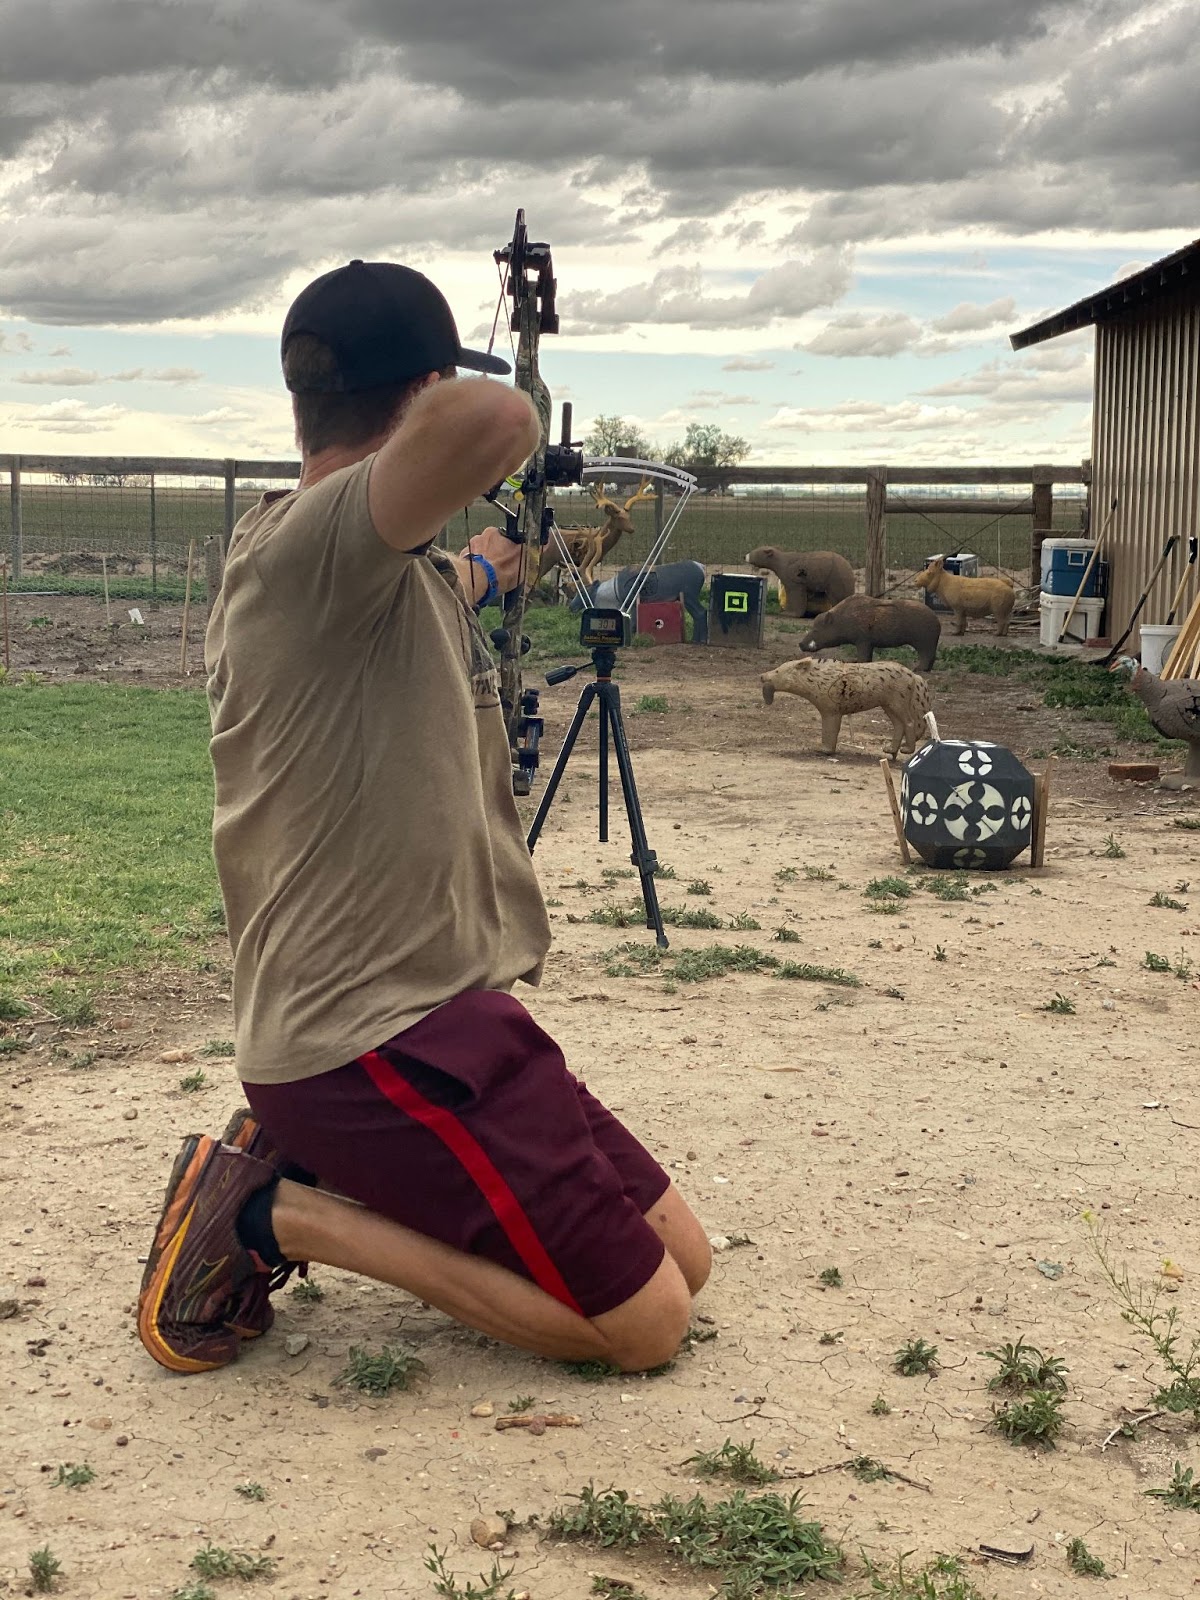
{"left": 1091, "top": 286, "right": 1200, "bottom": 650}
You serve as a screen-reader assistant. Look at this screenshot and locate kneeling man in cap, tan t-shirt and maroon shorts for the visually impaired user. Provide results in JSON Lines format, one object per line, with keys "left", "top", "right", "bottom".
{"left": 138, "top": 261, "right": 710, "bottom": 1373}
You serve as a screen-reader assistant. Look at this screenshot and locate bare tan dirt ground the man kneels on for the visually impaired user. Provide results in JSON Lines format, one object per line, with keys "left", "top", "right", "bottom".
{"left": 0, "top": 598, "right": 1200, "bottom": 1600}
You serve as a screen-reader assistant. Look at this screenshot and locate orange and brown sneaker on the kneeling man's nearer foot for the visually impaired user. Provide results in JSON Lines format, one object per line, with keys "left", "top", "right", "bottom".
{"left": 138, "top": 1133, "right": 278, "bottom": 1373}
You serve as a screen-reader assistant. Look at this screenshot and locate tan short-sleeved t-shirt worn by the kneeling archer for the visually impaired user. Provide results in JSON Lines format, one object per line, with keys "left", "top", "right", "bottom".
{"left": 205, "top": 456, "right": 550, "bottom": 1083}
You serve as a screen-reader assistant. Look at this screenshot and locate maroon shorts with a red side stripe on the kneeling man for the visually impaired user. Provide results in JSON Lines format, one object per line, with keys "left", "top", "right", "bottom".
{"left": 243, "top": 990, "right": 670, "bottom": 1317}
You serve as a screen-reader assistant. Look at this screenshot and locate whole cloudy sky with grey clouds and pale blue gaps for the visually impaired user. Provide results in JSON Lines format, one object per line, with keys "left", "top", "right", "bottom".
{"left": 0, "top": 0, "right": 1200, "bottom": 464}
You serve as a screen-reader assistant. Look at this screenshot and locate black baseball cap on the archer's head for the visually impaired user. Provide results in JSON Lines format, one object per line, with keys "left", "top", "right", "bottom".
{"left": 280, "top": 261, "right": 512, "bottom": 394}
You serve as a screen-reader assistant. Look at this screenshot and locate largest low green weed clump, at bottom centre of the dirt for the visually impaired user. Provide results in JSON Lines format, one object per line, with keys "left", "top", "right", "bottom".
{"left": 550, "top": 1483, "right": 842, "bottom": 1600}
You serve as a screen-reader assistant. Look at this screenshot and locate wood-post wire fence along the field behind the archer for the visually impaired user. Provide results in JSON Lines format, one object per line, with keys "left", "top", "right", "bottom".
{"left": 0, "top": 456, "right": 1086, "bottom": 600}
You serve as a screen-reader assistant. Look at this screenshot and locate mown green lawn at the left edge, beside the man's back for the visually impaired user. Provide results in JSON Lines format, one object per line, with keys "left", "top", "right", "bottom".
{"left": 0, "top": 683, "right": 218, "bottom": 992}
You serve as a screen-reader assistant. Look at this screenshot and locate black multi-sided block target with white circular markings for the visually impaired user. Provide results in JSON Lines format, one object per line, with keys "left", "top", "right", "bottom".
{"left": 899, "top": 739, "right": 1034, "bottom": 870}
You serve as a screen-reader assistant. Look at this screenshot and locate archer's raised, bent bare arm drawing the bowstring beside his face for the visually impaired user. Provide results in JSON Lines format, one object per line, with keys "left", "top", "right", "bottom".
{"left": 368, "top": 378, "right": 539, "bottom": 550}
